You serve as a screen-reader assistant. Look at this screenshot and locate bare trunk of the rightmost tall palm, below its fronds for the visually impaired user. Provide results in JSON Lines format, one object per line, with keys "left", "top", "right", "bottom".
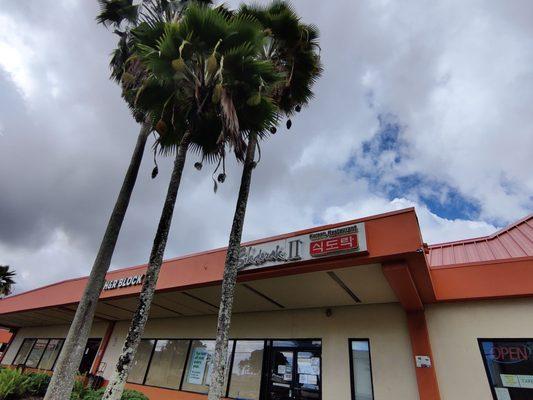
{"left": 208, "top": 133, "right": 257, "bottom": 400}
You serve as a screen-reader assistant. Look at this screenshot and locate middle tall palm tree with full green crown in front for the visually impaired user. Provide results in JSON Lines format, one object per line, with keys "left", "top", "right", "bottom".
{"left": 103, "top": 4, "right": 283, "bottom": 400}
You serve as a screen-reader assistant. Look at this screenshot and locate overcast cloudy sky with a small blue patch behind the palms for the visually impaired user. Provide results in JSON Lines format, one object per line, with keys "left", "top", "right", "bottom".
{"left": 0, "top": 0, "right": 533, "bottom": 292}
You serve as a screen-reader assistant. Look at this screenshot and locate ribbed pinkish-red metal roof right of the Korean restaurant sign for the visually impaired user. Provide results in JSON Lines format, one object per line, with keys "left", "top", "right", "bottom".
{"left": 428, "top": 214, "right": 533, "bottom": 268}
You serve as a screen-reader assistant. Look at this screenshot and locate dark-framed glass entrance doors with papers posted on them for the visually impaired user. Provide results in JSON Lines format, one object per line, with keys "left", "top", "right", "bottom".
{"left": 267, "top": 340, "right": 321, "bottom": 400}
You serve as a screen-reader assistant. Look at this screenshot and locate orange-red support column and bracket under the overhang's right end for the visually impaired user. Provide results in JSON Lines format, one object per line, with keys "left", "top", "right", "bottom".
{"left": 383, "top": 261, "right": 440, "bottom": 400}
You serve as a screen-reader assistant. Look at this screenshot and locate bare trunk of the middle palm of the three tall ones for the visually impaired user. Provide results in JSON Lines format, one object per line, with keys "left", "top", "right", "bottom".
{"left": 102, "top": 133, "right": 191, "bottom": 400}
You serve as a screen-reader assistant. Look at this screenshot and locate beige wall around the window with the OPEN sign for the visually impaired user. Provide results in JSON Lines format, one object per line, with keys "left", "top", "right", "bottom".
{"left": 426, "top": 299, "right": 533, "bottom": 400}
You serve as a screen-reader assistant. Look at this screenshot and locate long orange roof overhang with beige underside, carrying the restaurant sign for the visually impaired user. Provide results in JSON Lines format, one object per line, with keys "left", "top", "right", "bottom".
{"left": 0, "top": 208, "right": 435, "bottom": 327}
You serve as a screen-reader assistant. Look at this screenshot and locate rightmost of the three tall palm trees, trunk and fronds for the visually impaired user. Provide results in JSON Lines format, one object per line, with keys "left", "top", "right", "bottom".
{"left": 208, "top": 1, "right": 322, "bottom": 400}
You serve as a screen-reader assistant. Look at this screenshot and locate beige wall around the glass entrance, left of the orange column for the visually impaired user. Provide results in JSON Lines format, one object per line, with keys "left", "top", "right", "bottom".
{"left": 98, "top": 304, "right": 418, "bottom": 400}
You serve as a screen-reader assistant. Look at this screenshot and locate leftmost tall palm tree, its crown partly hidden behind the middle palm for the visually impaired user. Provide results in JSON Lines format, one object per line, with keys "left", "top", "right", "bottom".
{"left": 45, "top": 0, "right": 173, "bottom": 400}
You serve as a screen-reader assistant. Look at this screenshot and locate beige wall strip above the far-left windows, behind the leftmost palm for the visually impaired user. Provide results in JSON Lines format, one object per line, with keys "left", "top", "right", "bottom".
{"left": 2, "top": 322, "right": 107, "bottom": 364}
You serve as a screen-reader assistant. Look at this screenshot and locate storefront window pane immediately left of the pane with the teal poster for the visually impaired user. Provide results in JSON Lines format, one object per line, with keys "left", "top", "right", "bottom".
{"left": 146, "top": 340, "right": 189, "bottom": 389}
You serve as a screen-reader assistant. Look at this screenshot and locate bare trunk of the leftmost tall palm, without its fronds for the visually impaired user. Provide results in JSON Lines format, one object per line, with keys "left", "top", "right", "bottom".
{"left": 45, "top": 121, "right": 151, "bottom": 400}
